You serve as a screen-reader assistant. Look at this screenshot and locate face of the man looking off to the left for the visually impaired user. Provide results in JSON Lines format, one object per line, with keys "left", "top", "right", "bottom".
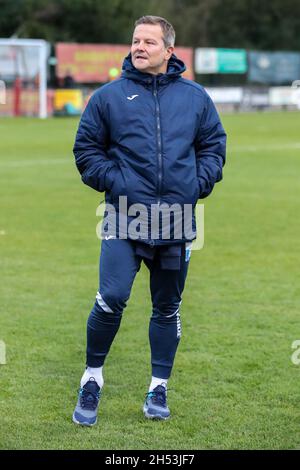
{"left": 131, "top": 24, "right": 174, "bottom": 75}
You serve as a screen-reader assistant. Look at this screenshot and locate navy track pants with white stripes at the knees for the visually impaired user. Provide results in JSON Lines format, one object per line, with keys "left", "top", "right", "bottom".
{"left": 86, "top": 239, "right": 189, "bottom": 379}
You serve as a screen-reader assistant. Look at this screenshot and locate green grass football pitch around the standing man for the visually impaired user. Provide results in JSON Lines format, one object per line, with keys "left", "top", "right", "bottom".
{"left": 0, "top": 112, "right": 300, "bottom": 450}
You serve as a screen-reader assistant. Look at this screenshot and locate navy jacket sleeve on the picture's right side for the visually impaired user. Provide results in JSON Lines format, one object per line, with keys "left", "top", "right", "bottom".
{"left": 195, "top": 92, "right": 226, "bottom": 199}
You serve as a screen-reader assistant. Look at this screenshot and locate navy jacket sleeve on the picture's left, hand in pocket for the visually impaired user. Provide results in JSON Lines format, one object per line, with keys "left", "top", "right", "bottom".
{"left": 73, "top": 95, "right": 117, "bottom": 191}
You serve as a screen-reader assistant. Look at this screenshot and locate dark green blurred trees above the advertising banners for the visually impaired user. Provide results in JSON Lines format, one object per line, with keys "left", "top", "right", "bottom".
{"left": 0, "top": 0, "right": 300, "bottom": 51}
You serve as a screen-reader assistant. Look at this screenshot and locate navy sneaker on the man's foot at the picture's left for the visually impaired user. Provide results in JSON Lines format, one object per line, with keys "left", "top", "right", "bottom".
{"left": 73, "top": 377, "right": 101, "bottom": 426}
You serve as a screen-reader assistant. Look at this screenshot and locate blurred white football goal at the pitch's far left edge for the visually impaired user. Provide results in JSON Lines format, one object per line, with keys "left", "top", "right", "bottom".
{"left": 0, "top": 38, "right": 49, "bottom": 119}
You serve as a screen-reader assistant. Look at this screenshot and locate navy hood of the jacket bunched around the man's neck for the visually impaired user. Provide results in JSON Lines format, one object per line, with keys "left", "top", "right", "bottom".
{"left": 121, "top": 52, "right": 186, "bottom": 83}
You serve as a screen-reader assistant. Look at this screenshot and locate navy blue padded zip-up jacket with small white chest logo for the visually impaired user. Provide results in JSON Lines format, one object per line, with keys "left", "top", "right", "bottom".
{"left": 74, "top": 54, "right": 226, "bottom": 244}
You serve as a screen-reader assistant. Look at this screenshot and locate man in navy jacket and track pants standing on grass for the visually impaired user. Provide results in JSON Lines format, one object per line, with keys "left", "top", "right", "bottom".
{"left": 73, "top": 16, "right": 226, "bottom": 426}
